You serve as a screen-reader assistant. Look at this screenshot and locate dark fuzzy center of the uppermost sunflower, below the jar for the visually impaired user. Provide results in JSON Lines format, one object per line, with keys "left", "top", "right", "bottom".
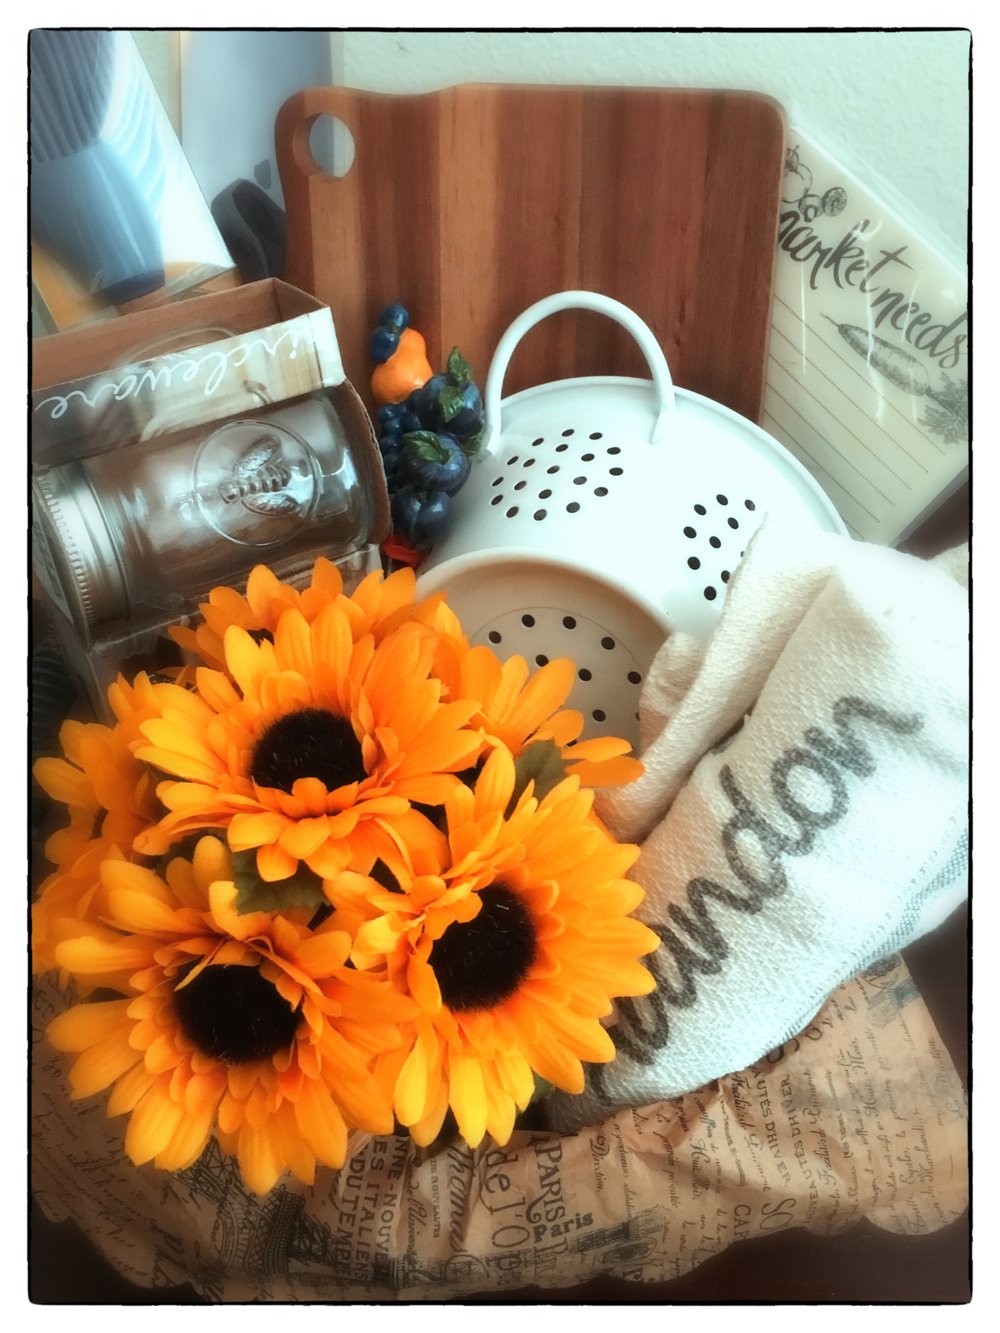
{"left": 249, "top": 708, "right": 368, "bottom": 792}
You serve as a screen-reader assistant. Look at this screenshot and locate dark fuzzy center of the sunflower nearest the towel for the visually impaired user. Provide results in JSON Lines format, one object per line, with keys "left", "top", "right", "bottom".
{"left": 431, "top": 884, "right": 536, "bottom": 1009}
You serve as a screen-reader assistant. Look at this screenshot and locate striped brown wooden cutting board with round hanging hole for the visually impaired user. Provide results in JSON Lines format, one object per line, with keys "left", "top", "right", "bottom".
{"left": 276, "top": 84, "right": 785, "bottom": 420}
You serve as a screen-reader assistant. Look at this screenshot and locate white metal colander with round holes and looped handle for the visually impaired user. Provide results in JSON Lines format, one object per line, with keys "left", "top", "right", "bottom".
{"left": 419, "top": 292, "right": 847, "bottom": 744}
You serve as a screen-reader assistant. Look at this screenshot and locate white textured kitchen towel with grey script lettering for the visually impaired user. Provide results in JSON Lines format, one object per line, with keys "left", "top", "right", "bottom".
{"left": 549, "top": 524, "right": 969, "bottom": 1130}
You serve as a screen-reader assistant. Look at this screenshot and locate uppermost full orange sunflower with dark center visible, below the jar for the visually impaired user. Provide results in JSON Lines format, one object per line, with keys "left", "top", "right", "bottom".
{"left": 136, "top": 600, "right": 481, "bottom": 881}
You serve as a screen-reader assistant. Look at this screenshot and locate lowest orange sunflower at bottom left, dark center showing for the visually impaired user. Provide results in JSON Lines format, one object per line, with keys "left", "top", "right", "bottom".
{"left": 48, "top": 837, "right": 413, "bottom": 1193}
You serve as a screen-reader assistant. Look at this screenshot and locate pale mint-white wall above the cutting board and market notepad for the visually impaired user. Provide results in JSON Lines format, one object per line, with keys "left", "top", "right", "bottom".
{"left": 338, "top": 29, "right": 975, "bottom": 253}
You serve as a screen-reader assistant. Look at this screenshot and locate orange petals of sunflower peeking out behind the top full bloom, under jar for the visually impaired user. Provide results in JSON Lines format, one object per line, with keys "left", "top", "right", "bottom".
{"left": 171, "top": 556, "right": 440, "bottom": 670}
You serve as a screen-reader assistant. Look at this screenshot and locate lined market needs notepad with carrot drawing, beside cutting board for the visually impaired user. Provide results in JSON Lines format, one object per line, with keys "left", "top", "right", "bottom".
{"left": 761, "top": 129, "right": 969, "bottom": 545}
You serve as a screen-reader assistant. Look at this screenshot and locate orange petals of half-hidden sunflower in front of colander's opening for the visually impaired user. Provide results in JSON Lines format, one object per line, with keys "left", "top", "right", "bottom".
{"left": 424, "top": 601, "right": 643, "bottom": 786}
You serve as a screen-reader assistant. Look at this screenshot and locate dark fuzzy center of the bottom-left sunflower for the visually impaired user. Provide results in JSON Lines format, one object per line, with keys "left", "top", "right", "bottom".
{"left": 173, "top": 964, "right": 299, "bottom": 1065}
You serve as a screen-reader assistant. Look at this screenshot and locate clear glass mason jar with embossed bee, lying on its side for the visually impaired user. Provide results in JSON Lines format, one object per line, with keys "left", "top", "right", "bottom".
{"left": 32, "top": 392, "right": 385, "bottom": 647}
